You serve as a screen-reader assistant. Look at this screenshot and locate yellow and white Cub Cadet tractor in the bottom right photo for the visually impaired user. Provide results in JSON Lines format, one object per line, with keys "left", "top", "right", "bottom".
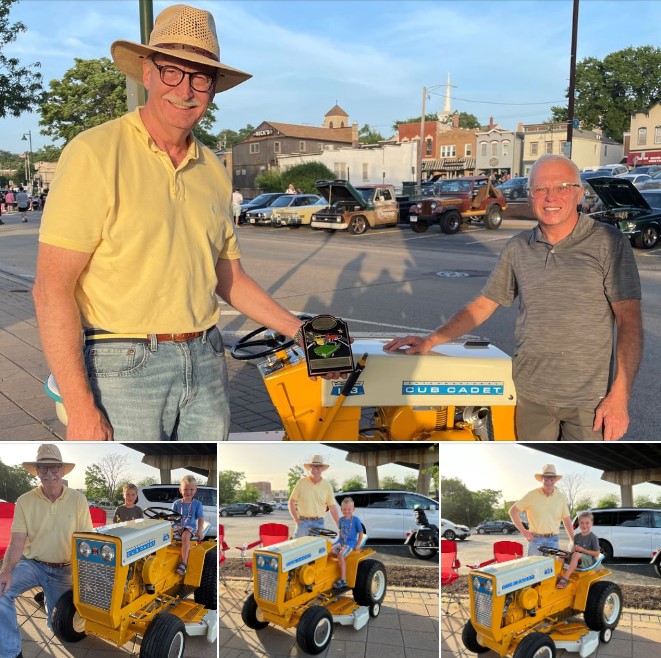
{"left": 462, "top": 547, "right": 622, "bottom": 658}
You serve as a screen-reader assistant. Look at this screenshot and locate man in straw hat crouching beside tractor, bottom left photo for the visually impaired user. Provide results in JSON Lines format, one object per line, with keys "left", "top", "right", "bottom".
{"left": 0, "top": 443, "right": 92, "bottom": 658}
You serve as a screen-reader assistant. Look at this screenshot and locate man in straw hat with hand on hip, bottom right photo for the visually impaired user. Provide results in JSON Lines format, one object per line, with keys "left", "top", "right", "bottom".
{"left": 510, "top": 464, "right": 574, "bottom": 555}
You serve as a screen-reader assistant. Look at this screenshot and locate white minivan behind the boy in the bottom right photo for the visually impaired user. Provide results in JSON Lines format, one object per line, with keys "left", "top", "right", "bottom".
{"left": 574, "top": 507, "right": 661, "bottom": 559}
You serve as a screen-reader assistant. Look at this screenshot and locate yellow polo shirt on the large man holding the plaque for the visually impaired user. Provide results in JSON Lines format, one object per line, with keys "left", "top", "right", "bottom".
{"left": 39, "top": 109, "right": 240, "bottom": 333}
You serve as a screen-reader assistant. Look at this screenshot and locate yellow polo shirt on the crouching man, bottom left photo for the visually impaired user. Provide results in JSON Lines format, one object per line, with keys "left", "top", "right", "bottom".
{"left": 11, "top": 486, "right": 92, "bottom": 562}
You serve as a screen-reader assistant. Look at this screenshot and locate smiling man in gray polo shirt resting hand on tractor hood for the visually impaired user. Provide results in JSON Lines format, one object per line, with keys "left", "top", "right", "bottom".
{"left": 384, "top": 155, "right": 643, "bottom": 441}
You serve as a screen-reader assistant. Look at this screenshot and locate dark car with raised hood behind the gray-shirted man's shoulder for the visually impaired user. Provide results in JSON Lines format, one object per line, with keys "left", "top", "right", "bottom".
{"left": 581, "top": 176, "right": 661, "bottom": 249}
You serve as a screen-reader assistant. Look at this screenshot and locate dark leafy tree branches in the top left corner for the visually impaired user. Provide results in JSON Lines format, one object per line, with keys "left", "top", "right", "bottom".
{"left": 0, "top": 0, "right": 42, "bottom": 117}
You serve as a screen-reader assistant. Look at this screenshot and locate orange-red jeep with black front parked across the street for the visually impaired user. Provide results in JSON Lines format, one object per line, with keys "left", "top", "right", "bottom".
{"left": 409, "top": 176, "right": 507, "bottom": 234}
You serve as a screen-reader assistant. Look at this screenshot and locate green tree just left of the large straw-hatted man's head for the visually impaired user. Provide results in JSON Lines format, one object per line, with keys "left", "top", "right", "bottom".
{"left": 39, "top": 57, "right": 127, "bottom": 144}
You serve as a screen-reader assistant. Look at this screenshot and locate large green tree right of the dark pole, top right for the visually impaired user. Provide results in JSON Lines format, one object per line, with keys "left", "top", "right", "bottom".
{"left": 551, "top": 46, "right": 661, "bottom": 141}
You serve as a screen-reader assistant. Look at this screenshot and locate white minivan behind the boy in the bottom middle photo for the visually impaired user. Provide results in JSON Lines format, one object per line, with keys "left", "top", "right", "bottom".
{"left": 335, "top": 489, "right": 439, "bottom": 540}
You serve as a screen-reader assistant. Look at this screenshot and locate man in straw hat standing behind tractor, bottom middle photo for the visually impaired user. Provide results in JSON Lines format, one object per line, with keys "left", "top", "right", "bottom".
{"left": 289, "top": 455, "right": 340, "bottom": 537}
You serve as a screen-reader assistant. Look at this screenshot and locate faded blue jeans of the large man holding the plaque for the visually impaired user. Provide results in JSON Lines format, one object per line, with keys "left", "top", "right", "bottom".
{"left": 85, "top": 327, "right": 230, "bottom": 441}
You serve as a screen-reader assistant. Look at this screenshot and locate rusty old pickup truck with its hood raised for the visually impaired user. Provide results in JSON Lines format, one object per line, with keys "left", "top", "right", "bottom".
{"left": 310, "top": 179, "right": 399, "bottom": 235}
